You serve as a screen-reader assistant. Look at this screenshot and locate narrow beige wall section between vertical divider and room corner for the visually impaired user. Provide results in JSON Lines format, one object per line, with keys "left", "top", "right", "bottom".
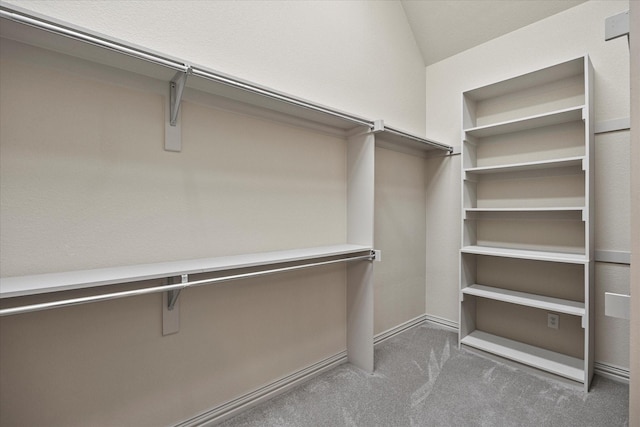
{"left": 374, "top": 148, "right": 427, "bottom": 333}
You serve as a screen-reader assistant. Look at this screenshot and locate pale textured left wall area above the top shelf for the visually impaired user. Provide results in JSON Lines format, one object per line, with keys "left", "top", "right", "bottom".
{"left": 8, "top": 0, "right": 425, "bottom": 134}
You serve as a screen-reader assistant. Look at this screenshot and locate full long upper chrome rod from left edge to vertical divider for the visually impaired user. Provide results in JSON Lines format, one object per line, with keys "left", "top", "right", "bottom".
{"left": 0, "top": 8, "right": 373, "bottom": 129}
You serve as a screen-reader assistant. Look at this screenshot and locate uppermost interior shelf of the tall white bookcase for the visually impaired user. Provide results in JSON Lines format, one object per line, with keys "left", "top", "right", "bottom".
{"left": 465, "top": 105, "right": 584, "bottom": 138}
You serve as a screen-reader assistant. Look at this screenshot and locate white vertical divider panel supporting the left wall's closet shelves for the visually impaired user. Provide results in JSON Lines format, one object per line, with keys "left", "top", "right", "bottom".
{"left": 347, "top": 133, "right": 375, "bottom": 372}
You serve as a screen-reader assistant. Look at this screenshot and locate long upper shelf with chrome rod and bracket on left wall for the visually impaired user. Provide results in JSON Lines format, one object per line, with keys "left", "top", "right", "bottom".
{"left": 0, "top": 2, "right": 453, "bottom": 153}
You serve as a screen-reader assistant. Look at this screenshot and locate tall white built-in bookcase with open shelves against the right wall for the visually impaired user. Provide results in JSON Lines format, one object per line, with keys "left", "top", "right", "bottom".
{"left": 460, "top": 56, "right": 594, "bottom": 390}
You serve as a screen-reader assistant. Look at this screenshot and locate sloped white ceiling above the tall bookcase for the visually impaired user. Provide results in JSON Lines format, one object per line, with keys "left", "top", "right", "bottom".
{"left": 401, "top": 0, "right": 585, "bottom": 65}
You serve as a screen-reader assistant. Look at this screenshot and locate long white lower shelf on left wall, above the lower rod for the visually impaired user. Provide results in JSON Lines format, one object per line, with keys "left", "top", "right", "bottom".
{"left": 0, "top": 244, "right": 371, "bottom": 298}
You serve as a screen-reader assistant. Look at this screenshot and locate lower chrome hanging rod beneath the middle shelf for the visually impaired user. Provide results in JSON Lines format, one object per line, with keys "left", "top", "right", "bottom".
{"left": 0, "top": 253, "right": 374, "bottom": 316}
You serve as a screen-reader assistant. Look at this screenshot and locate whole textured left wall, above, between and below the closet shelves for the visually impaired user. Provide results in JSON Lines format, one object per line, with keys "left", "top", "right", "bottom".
{"left": 0, "top": 1, "right": 425, "bottom": 426}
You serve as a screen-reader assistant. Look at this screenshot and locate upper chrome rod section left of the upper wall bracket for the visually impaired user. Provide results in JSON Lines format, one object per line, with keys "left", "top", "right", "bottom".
{"left": 0, "top": 7, "right": 189, "bottom": 72}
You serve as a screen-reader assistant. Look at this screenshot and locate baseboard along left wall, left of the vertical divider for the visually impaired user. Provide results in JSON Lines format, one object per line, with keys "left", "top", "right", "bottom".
{"left": 175, "top": 351, "right": 347, "bottom": 427}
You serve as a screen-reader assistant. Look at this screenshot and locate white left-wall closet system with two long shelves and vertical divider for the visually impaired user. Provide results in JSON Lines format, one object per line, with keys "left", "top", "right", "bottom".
{"left": 0, "top": 4, "right": 453, "bottom": 371}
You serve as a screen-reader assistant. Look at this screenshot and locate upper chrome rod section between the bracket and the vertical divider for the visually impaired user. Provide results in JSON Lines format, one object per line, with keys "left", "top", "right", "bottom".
{"left": 193, "top": 66, "right": 373, "bottom": 129}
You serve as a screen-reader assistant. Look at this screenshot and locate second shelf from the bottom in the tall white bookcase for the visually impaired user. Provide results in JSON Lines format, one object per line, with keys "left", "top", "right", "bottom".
{"left": 462, "top": 284, "right": 585, "bottom": 316}
